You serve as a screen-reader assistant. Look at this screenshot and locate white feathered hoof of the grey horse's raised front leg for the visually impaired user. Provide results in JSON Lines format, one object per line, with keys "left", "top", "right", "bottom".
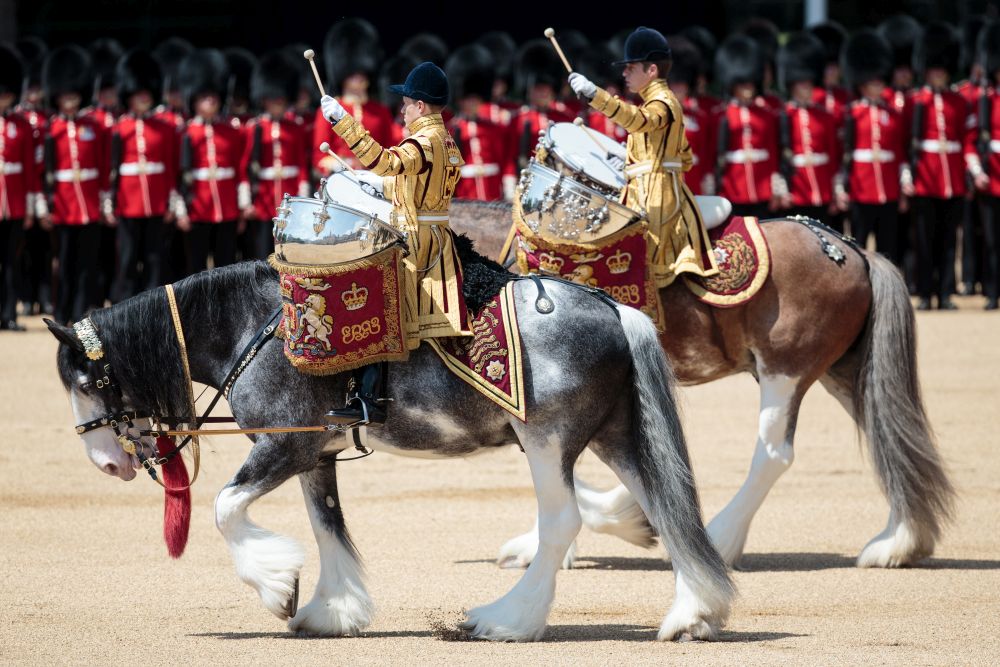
{"left": 231, "top": 528, "right": 305, "bottom": 620}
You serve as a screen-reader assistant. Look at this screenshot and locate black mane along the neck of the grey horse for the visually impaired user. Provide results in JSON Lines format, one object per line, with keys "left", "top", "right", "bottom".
{"left": 90, "top": 262, "right": 277, "bottom": 415}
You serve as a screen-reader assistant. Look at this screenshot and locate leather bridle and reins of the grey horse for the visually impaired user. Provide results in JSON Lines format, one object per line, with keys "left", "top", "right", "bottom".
{"left": 73, "top": 285, "right": 372, "bottom": 491}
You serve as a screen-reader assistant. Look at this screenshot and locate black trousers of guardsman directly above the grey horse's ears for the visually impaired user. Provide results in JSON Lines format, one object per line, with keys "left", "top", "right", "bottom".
{"left": 55, "top": 223, "right": 102, "bottom": 324}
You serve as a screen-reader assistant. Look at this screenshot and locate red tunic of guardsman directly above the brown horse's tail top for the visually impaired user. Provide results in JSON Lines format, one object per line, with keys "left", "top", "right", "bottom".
{"left": 847, "top": 99, "right": 907, "bottom": 204}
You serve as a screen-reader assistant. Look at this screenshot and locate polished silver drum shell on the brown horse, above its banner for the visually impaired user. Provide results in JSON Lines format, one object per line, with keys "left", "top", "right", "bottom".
{"left": 518, "top": 160, "right": 641, "bottom": 243}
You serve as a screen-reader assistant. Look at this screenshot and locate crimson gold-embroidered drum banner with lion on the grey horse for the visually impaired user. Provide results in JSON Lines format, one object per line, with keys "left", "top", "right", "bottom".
{"left": 268, "top": 245, "right": 408, "bottom": 375}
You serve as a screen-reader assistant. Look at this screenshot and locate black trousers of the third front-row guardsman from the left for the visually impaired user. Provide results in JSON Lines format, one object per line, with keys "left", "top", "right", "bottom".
{"left": 113, "top": 217, "right": 165, "bottom": 302}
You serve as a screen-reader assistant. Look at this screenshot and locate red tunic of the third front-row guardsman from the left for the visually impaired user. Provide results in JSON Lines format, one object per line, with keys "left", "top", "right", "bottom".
{"left": 111, "top": 114, "right": 180, "bottom": 218}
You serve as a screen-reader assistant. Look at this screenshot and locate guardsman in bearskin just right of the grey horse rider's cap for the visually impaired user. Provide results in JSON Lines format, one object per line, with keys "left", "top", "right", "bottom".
{"left": 445, "top": 44, "right": 517, "bottom": 201}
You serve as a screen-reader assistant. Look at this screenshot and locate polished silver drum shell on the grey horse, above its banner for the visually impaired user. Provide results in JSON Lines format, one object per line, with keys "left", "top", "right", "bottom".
{"left": 273, "top": 195, "right": 405, "bottom": 265}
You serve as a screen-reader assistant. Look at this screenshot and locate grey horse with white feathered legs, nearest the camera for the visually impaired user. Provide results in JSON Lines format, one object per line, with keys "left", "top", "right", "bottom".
{"left": 49, "top": 263, "right": 735, "bottom": 641}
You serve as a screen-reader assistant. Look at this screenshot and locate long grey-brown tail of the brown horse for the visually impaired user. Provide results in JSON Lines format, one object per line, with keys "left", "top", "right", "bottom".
{"left": 854, "top": 253, "right": 955, "bottom": 555}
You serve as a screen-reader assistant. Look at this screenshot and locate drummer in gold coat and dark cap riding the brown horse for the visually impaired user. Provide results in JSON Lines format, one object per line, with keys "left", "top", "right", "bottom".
{"left": 569, "top": 27, "right": 719, "bottom": 288}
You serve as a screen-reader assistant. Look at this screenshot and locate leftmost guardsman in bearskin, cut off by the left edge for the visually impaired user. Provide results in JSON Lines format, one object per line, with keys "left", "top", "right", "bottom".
{"left": 0, "top": 44, "right": 39, "bottom": 331}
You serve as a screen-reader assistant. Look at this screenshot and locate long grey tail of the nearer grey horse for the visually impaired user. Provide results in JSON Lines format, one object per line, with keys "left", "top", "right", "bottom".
{"left": 618, "top": 306, "right": 736, "bottom": 621}
